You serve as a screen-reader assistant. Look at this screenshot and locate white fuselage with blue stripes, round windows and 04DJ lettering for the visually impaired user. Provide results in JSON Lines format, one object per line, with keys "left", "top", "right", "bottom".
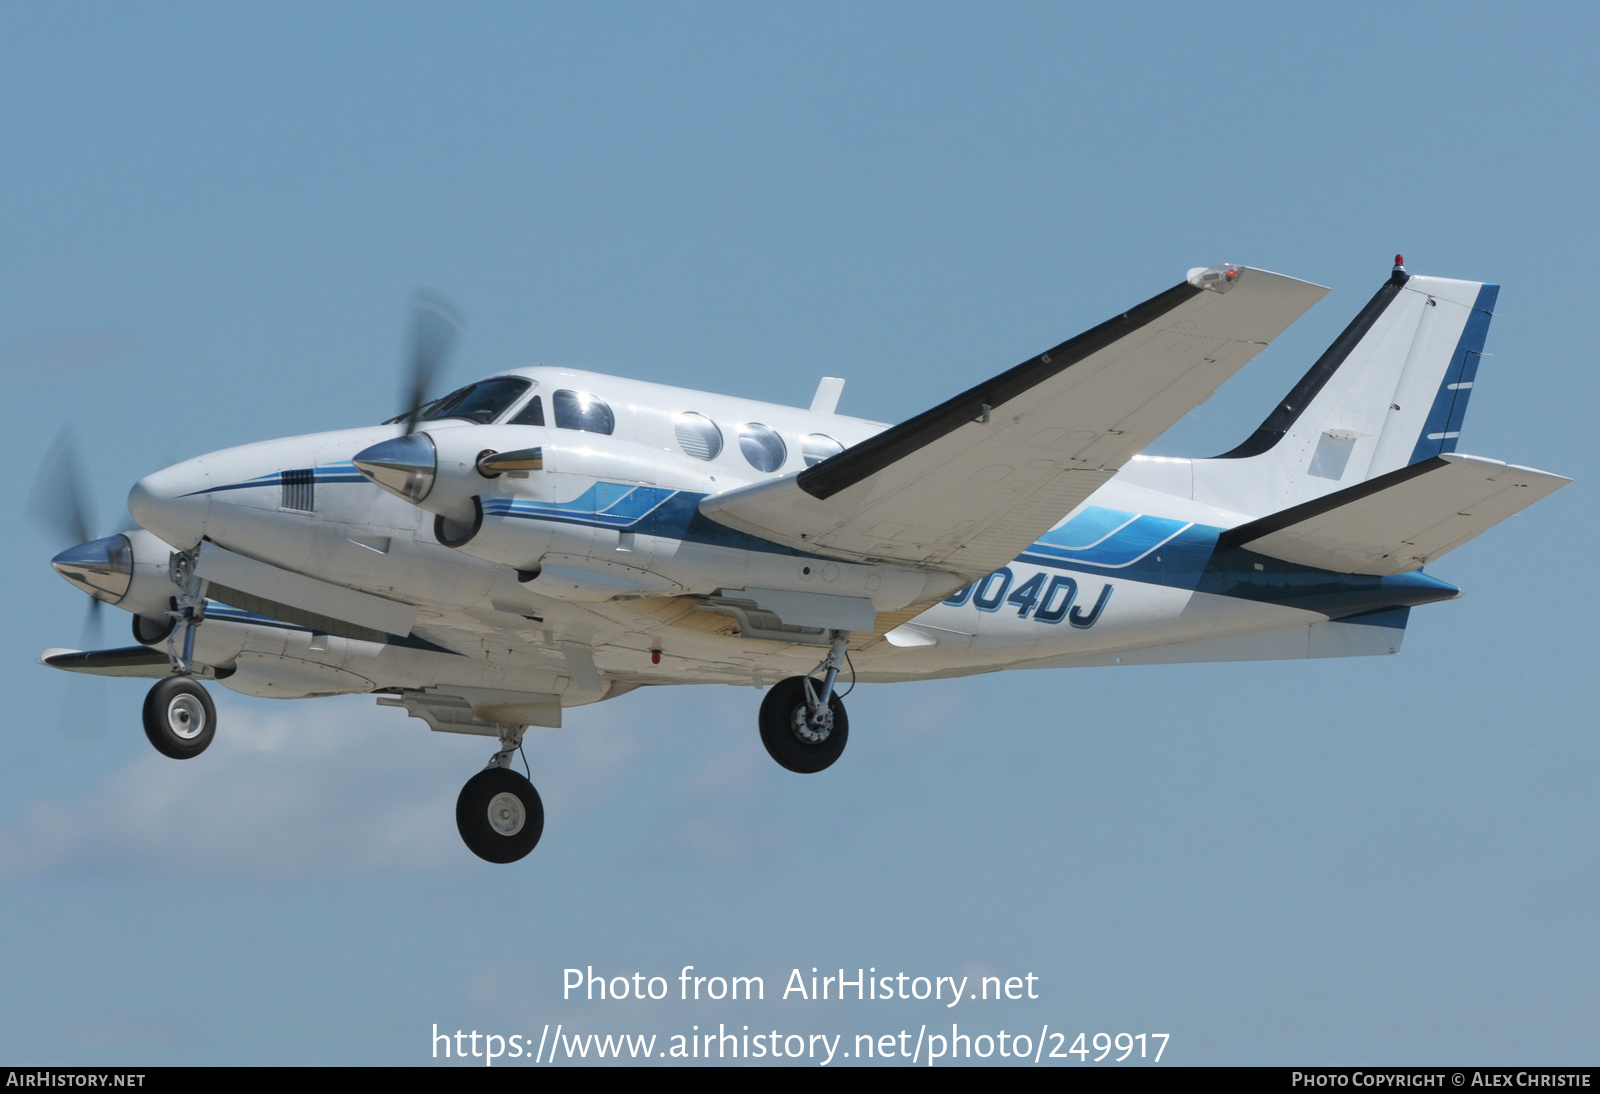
{"left": 123, "top": 368, "right": 1442, "bottom": 705}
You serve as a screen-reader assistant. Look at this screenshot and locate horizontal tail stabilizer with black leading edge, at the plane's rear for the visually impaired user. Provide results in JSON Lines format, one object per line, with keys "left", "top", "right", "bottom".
{"left": 1221, "top": 453, "right": 1573, "bottom": 574}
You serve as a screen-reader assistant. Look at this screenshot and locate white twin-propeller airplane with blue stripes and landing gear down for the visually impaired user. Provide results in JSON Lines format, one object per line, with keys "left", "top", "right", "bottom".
{"left": 40, "top": 256, "right": 1570, "bottom": 862}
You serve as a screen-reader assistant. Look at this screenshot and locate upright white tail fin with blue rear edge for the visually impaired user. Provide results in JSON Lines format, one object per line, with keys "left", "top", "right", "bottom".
{"left": 1194, "top": 267, "right": 1499, "bottom": 513}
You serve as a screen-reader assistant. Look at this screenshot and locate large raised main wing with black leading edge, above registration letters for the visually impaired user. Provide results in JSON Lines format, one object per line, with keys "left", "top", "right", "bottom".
{"left": 699, "top": 266, "right": 1328, "bottom": 579}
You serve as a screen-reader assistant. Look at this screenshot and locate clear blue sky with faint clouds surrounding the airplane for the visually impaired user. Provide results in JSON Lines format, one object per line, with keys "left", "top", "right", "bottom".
{"left": 0, "top": 3, "right": 1600, "bottom": 1064}
